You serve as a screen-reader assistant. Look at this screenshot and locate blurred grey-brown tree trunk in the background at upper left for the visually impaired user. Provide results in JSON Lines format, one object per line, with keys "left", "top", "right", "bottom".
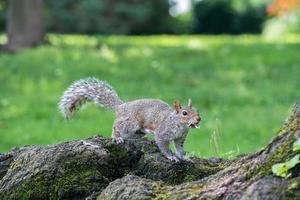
{"left": 4, "top": 0, "right": 45, "bottom": 52}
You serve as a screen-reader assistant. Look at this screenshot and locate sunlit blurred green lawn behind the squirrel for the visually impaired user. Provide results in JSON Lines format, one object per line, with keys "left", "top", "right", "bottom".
{"left": 0, "top": 34, "right": 300, "bottom": 156}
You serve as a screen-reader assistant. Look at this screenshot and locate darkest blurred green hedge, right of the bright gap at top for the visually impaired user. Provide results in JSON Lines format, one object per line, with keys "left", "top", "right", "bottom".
{"left": 193, "top": 0, "right": 267, "bottom": 34}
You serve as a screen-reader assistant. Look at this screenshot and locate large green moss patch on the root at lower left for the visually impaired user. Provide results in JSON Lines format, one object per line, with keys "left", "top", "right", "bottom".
{"left": 0, "top": 155, "right": 113, "bottom": 199}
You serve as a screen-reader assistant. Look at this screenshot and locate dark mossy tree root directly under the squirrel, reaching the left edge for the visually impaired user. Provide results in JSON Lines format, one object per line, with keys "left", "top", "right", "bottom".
{"left": 0, "top": 136, "right": 230, "bottom": 200}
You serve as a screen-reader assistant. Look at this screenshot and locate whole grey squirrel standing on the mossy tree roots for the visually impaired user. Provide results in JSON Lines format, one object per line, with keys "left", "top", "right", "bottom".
{"left": 59, "top": 78, "right": 201, "bottom": 162}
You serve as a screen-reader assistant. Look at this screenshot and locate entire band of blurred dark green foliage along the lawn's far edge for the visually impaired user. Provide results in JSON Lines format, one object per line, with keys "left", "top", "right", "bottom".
{"left": 0, "top": 0, "right": 278, "bottom": 35}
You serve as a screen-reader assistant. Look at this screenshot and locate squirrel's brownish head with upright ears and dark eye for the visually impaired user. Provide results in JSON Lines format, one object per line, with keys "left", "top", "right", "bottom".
{"left": 174, "top": 99, "right": 201, "bottom": 128}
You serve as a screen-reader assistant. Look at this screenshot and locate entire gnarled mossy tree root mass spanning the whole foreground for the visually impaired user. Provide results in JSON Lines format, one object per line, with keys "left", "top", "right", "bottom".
{"left": 0, "top": 103, "right": 300, "bottom": 199}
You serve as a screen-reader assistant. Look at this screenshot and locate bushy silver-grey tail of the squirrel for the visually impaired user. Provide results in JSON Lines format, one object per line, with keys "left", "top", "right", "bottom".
{"left": 59, "top": 78, "right": 122, "bottom": 119}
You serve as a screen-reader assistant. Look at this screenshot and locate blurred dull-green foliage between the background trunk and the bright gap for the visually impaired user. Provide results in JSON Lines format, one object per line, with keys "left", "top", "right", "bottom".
{"left": 45, "top": 0, "right": 171, "bottom": 34}
